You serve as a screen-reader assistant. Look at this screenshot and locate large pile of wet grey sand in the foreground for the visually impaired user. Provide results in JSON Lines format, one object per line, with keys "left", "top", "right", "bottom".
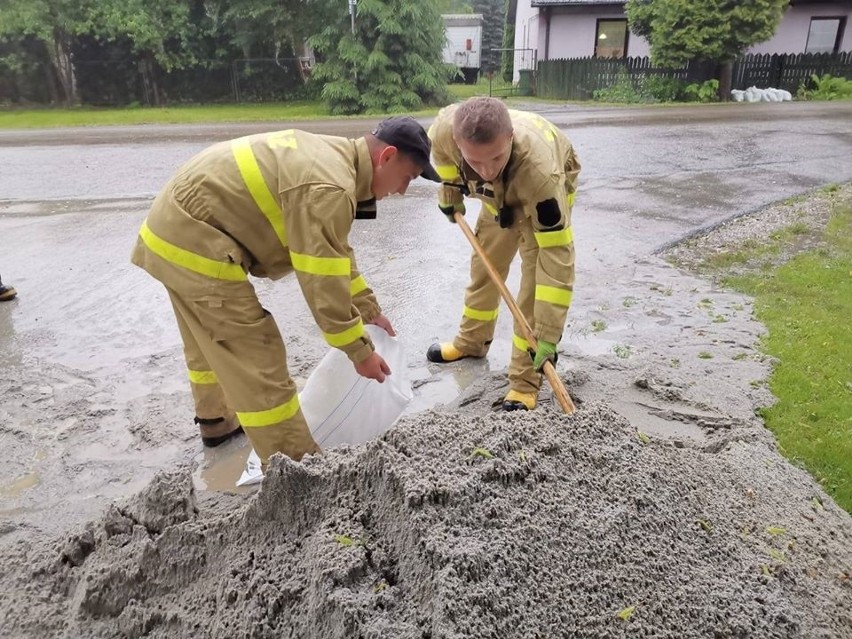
{"left": 0, "top": 390, "right": 852, "bottom": 639}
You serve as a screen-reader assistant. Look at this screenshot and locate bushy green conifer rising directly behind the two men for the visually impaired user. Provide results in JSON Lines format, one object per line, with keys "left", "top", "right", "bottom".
{"left": 309, "top": 0, "right": 450, "bottom": 114}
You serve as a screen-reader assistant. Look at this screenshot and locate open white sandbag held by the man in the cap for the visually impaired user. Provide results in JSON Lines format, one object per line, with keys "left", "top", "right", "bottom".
{"left": 237, "top": 325, "right": 414, "bottom": 486}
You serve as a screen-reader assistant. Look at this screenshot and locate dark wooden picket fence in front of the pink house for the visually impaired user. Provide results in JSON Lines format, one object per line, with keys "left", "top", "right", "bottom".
{"left": 535, "top": 51, "right": 852, "bottom": 100}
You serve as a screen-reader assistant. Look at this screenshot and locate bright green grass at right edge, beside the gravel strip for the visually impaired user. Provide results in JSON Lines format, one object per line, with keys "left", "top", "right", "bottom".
{"left": 725, "top": 203, "right": 852, "bottom": 512}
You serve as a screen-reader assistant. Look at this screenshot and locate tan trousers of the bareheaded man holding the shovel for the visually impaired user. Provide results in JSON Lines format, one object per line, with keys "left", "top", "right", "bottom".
{"left": 453, "top": 206, "right": 541, "bottom": 393}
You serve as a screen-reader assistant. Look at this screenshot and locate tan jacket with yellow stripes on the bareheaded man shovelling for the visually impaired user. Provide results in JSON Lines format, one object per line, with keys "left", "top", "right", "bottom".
{"left": 429, "top": 105, "right": 580, "bottom": 343}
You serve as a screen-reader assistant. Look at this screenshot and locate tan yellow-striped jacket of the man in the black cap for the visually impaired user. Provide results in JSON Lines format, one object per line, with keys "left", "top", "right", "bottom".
{"left": 132, "top": 129, "right": 381, "bottom": 362}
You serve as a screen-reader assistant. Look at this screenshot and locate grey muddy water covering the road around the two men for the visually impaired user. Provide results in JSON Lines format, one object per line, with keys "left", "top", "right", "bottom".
{"left": 0, "top": 104, "right": 852, "bottom": 541}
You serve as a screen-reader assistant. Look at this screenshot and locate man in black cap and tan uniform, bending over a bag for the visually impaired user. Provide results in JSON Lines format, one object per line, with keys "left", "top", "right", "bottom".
{"left": 132, "top": 117, "right": 440, "bottom": 466}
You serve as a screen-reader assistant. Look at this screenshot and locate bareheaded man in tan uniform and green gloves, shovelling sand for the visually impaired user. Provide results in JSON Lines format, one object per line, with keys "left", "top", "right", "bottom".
{"left": 426, "top": 98, "right": 580, "bottom": 410}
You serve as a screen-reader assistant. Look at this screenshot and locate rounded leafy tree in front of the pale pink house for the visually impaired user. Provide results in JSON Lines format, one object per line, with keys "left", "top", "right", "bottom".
{"left": 625, "top": 0, "right": 789, "bottom": 100}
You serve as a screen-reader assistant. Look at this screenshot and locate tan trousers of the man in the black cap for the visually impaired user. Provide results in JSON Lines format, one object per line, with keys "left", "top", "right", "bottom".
{"left": 167, "top": 285, "right": 321, "bottom": 466}
